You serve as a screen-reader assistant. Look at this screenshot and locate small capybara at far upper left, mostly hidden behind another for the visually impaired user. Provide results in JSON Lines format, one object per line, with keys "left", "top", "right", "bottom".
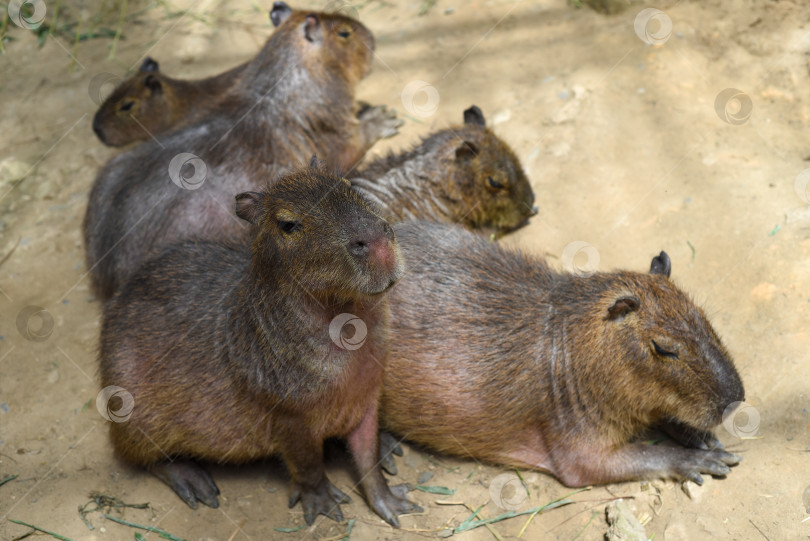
{"left": 93, "top": 57, "right": 247, "bottom": 147}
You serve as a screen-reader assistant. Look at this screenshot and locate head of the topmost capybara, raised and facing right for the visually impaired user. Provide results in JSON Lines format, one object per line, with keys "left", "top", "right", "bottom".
{"left": 270, "top": 2, "right": 374, "bottom": 85}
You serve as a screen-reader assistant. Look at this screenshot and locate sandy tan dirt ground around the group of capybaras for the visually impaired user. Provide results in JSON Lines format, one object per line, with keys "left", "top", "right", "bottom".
{"left": 0, "top": 0, "right": 810, "bottom": 541}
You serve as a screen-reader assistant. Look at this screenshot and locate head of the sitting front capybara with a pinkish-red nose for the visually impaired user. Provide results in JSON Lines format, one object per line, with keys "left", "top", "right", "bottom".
{"left": 236, "top": 159, "right": 403, "bottom": 299}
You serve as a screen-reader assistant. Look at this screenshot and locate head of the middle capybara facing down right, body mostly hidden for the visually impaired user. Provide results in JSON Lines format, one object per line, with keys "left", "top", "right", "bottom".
{"left": 451, "top": 105, "right": 537, "bottom": 233}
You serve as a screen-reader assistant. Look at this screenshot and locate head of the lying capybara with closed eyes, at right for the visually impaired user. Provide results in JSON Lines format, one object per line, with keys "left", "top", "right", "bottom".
{"left": 584, "top": 252, "right": 745, "bottom": 430}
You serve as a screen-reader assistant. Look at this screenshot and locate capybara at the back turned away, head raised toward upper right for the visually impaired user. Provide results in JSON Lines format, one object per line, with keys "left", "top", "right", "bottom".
{"left": 83, "top": 2, "right": 397, "bottom": 300}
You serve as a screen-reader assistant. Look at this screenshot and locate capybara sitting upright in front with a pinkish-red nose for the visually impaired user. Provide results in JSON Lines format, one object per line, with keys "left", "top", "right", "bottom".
{"left": 100, "top": 168, "right": 418, "bottom": 526}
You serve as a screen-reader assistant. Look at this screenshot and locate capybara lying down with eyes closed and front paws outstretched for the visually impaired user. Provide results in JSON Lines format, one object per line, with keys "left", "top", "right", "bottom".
{"left": 380, "top": 222, "right": 744, "bottom": 486}
